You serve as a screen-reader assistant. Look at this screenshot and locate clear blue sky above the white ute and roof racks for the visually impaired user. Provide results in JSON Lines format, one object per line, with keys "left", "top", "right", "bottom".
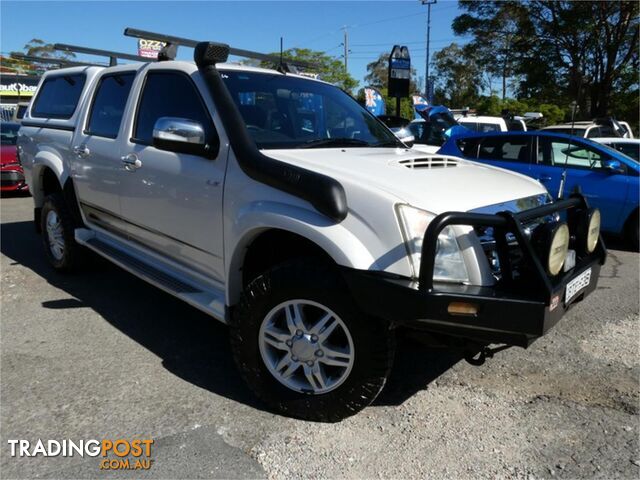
{"left": 0, "top": 0, "right": 464, "bottom": 86}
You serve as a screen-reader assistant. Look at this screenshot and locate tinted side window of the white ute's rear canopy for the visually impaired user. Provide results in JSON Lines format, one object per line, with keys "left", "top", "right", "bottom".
{"left": 31, "top": 73, "right": 86, "bottom": 119}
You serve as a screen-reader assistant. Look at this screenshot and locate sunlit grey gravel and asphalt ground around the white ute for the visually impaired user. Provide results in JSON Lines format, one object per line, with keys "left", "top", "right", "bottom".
{"left": 0, "top": 198, "right": 640, "bottom": 479}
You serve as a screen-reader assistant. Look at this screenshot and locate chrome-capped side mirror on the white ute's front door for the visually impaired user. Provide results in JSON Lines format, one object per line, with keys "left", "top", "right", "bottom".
{"left": 153, "top": 117, "right": 210, "bottom": 155}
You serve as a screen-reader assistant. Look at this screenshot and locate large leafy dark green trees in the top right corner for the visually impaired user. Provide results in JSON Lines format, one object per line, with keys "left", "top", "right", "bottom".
{"left": 453, "top": 0, "right": 640, "bottom": 121}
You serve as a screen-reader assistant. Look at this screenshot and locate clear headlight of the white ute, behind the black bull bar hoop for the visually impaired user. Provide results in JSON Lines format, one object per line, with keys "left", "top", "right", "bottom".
{"left": 397, "top": 205, "right": 469, "bottom": 283}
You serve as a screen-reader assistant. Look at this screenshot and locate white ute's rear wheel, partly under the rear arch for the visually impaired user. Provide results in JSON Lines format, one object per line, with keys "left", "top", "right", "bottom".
{"left": 40, "top": 193, "right": 85, "bottom": 272}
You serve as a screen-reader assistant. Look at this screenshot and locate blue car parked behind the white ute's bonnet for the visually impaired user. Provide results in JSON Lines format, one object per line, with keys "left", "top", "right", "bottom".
{"left": 439, "top": 131, "right": 640, "bottom": 248}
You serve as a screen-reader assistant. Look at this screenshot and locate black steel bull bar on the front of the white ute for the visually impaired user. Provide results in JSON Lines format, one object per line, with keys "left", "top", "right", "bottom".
{"left": 343, "top": 195, "right": 606, "bottom": 347}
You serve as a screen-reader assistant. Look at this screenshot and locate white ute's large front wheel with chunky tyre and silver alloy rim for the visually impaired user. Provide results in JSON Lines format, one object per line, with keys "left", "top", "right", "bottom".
{"left": 230, "top": 259, "right": 395, "bottom": 422}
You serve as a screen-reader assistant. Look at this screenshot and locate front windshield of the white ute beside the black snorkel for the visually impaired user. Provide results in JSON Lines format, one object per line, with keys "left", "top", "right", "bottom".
{"left": 222, "top": 70, "right": 404, "bottom": 149}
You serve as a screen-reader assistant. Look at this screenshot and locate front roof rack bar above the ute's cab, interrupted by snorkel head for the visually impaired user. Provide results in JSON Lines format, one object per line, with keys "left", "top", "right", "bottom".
{"left": 124, "top": 27, "right": 318, "bottom": 73}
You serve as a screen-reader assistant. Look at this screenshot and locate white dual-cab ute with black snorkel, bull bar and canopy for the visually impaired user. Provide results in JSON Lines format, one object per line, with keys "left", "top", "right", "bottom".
{"left": 18, "top": 38, "right": 606, "bottom": 421}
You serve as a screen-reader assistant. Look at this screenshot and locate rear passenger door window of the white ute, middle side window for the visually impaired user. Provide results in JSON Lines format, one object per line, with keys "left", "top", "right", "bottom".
{"left": 85, "top": 72, "right": 135, "bottom": 138}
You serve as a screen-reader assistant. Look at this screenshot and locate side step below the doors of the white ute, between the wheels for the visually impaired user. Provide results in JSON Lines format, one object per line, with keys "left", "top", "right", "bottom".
{"left": 75, "top": 229, "right": 226, "bottom": 323}
